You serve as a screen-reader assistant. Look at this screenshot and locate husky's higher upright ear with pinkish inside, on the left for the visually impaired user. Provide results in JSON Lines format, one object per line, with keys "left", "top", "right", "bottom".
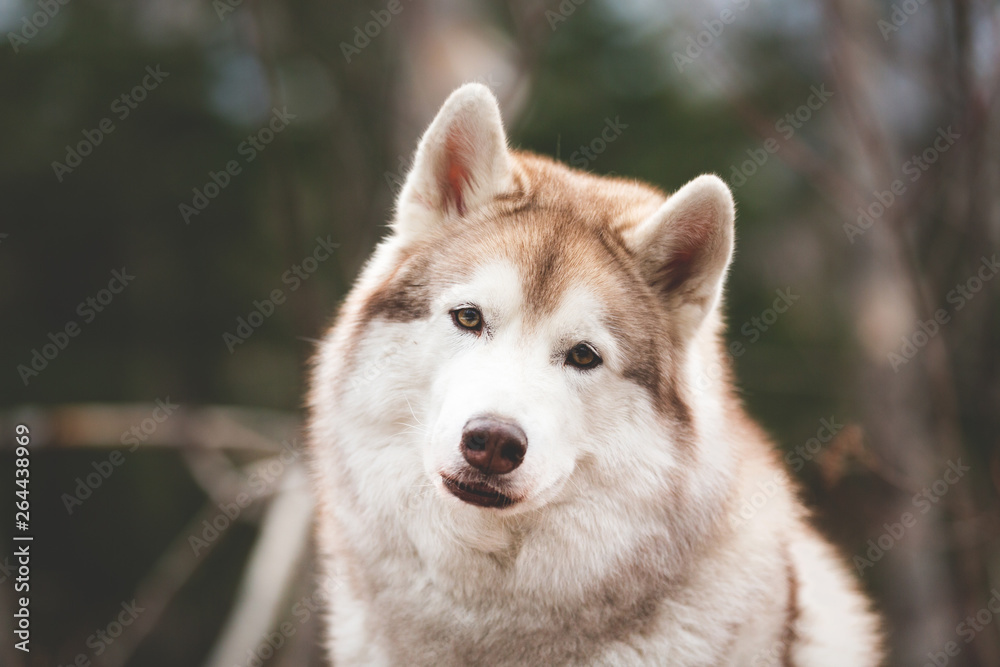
{"left": 394, "top": 83, "right": 513, "bottom": 238}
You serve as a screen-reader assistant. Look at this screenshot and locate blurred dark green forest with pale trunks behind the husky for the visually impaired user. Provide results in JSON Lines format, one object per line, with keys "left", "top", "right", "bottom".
{"left": 0, "top": 0, "right": 1000, "bottom": 667}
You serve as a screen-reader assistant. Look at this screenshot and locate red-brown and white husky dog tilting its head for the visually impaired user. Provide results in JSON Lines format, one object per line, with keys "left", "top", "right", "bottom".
{"left": 309, "top": 84, "right": 882, "bottom": 667}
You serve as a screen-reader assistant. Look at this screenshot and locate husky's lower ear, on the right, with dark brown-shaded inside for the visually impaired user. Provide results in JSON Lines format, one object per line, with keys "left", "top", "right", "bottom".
{"left": 627, "top": 175, "right": 736, "bottom": 337}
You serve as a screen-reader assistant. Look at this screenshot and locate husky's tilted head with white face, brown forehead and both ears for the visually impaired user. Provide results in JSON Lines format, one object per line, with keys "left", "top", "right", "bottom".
{"left": 313, "top": 84, "right": 734, "bottom": 514}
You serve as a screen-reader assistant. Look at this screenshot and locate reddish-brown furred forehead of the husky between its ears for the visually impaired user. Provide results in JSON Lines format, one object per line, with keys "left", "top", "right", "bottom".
{"left": 362, "top": 152, "right": 665, "bottom": 322}
